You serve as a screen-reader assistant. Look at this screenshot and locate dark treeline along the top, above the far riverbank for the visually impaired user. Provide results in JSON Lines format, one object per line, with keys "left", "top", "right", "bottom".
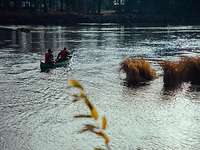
{"left": 0, "top": 0, "right": 200, "bottom": 16}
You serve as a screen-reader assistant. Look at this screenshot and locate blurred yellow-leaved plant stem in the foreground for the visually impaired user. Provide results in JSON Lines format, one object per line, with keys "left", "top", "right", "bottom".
{"left": 68, "top": 80, "right": 110, "bottom": 150}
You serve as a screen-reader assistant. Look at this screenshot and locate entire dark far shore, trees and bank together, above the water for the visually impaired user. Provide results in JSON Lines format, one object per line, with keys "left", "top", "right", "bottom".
{"left": 0, "top": 0, "right": 200, "bottom": 24}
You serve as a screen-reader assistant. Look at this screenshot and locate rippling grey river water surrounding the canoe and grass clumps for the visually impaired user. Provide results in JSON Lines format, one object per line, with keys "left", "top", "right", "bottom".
{"left": 0, "top": 24, "right": 200, "bottom": 150}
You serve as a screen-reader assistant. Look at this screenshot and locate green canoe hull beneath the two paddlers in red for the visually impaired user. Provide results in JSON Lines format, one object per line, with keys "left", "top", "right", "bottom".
{"left": 40, "top": 57, "right": 71, "bottom": 72}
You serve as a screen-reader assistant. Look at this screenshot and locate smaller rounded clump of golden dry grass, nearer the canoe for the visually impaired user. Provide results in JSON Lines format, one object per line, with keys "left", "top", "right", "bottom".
{"left": 120, "top": 58, "right": 156, "bottom": 85}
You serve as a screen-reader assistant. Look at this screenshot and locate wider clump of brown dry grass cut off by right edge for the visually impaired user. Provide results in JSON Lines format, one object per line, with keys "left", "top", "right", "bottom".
{"left": 160, "top": 57, "right": 200, "bottom": 86}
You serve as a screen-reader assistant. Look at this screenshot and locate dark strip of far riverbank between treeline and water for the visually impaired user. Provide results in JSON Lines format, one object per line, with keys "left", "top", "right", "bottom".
{"left": 0, "top": 12, "right": 200, "bottom": 26}
